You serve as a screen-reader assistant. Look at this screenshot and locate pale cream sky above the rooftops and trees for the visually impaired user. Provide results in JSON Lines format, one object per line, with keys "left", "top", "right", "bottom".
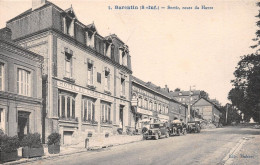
{"left": 0, "top": 0, "right": 258, "bottom": 104}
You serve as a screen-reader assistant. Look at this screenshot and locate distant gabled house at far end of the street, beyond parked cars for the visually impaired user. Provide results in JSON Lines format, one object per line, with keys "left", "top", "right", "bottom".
{"left": 191, "top": 98, "right": 221, "bottom": 123}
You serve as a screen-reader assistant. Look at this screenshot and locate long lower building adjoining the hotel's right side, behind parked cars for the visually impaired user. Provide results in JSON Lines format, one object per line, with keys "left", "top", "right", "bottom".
{"left": 131, "top": 76, "right": 187, "bottom": 129}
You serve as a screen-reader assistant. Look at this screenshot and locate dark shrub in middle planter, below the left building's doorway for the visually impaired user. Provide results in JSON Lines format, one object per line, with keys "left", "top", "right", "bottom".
{"left": 21, "top": 133, "right": 42, "bottom": 148}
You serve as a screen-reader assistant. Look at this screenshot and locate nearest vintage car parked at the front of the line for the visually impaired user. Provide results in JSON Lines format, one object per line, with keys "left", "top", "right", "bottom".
{"left": 143, "top": 123, "right": 169, "bottom": 140}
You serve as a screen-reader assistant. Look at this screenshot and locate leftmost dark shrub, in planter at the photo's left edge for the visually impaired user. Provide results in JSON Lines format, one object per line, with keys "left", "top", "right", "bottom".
{"left": 0, "top": 134, "right": 20, "bottom": 153}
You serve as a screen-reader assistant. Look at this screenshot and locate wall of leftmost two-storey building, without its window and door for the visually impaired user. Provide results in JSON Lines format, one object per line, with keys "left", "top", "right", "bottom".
{"left": 0, "top": 40, "right": 43, "bottom": 136}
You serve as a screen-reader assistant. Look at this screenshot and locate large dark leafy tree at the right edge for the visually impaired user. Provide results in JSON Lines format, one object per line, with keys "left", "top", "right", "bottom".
{"left": 228, "top": 2, "right": 260, "bottom": 122}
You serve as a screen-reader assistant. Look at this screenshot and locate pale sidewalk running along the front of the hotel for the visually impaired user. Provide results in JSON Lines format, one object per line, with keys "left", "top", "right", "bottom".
{"left": 4, "top": 135, "right": 143, "bottom": 165}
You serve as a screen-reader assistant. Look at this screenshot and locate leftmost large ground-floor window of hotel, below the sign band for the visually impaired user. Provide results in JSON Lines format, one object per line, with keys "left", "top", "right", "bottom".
{"left": 58, "top": 94, "right": 75, "bottom": 119}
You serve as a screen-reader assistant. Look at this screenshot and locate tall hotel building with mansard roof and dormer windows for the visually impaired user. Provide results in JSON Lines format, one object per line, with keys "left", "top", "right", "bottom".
{"left": 7, "top": 1, "right": 134, "bottom": 144}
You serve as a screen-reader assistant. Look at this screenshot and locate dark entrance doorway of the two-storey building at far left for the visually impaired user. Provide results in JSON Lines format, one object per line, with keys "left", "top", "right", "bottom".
{"left": 17, "top": 111, "right": 30, "bottom": 140}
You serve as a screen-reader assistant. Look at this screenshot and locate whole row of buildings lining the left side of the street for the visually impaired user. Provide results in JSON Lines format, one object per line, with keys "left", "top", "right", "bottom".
{"left": 0, "top": 0, "right": 220, "bottom": 144}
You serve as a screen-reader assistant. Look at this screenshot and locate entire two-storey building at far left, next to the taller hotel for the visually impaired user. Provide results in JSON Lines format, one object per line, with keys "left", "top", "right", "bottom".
{"left": 0, "top": 28, "right": 43, "bottom": 139}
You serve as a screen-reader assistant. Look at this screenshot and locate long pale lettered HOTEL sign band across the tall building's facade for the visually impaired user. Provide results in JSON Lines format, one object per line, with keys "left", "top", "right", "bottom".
{"left": 57, "top": 80, "right": 113, "bottom": 101}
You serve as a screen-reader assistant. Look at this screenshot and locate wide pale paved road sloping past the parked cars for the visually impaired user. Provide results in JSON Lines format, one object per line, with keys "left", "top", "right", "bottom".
{"left": 24, "top": 127, "right": 260, "bottom": 165}
